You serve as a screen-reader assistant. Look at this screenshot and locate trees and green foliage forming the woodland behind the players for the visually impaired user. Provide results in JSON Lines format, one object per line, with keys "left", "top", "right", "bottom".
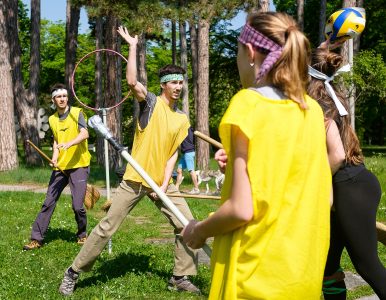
{"left": 0, "top": 0, "right": 386, "bottom": 171}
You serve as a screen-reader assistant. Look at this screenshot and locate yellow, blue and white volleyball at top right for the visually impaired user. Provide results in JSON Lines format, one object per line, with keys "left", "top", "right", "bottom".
{"left": 324, "top": 7, "right": 366, "bottom": 42}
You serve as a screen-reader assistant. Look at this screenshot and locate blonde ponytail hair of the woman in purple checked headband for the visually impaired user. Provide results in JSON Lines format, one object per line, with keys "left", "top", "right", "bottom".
{"left": 248, "top": 12, "right": 311, "bottom": 109}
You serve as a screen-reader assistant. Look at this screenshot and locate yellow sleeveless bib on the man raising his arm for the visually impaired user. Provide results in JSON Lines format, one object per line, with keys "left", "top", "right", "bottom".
{"left": 123, "top": 97, "right": 190, "bottom": 187}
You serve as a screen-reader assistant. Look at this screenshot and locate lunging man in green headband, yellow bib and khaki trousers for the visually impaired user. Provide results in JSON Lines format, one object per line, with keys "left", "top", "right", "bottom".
{"left": 59, "top": 27, "right": 200, "bottom": 295}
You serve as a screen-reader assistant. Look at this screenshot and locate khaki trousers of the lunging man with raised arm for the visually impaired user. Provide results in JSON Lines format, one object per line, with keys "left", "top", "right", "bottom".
{"left": 71, "top": 181, "right": 198, "bottom": 276}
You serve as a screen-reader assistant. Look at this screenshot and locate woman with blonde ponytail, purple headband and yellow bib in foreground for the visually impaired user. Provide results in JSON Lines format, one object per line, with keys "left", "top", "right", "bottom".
{"left": 182, "top": 12, "right": 331, "bottom": 300}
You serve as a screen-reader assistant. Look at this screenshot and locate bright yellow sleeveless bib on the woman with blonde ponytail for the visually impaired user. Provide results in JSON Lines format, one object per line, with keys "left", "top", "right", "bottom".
{"left": 209, "top": 90, "right": 331, "bottom": 300}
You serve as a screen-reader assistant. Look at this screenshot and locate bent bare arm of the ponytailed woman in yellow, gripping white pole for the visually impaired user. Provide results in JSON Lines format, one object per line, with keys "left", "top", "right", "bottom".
{"left": 183, "top": 127, "right": 253, "bottom": 249}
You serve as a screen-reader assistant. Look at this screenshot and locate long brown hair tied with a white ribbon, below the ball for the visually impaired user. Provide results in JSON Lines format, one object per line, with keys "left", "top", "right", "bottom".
{"left": 308, "top": 48, "right": 363, "bottom": 164}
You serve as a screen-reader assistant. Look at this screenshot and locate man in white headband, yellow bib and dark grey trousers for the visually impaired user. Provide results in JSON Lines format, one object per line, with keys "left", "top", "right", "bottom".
{"left": 23, "top": 84, "right": 91, "bottom": 250}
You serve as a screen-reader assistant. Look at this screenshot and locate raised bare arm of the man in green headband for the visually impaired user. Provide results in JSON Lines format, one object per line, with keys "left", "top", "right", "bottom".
{"left": 117, "top": 26, "right": 147, "bottom": 102}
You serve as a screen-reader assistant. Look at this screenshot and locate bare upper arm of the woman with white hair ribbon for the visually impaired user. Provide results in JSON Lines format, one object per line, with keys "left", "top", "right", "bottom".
{"left": 326, "top": 120, "right": 346, "bottom": 174}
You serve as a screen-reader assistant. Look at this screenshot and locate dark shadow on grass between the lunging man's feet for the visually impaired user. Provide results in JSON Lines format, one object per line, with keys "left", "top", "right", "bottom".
{"left": 77, "top": 253, "right": 170, "bottom": 288}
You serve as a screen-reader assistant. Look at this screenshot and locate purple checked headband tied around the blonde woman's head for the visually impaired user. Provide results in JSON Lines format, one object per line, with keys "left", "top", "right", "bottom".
{"left": 238, "top": 24, "right": 283, "bottom": 82}
